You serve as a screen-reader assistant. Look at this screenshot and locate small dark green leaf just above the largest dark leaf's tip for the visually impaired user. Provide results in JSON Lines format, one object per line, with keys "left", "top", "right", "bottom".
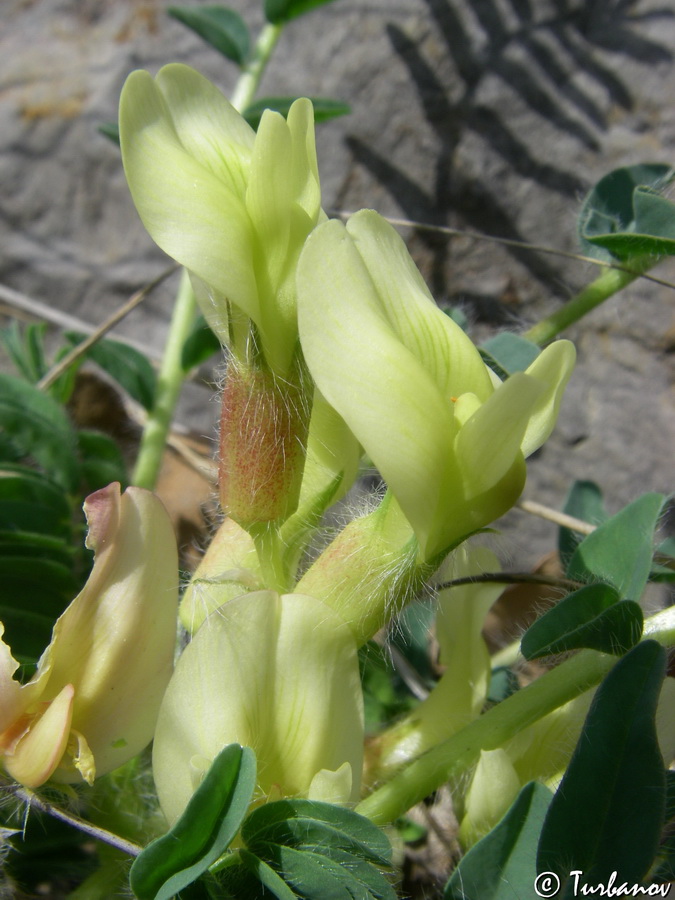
{"left": 520, "top": 584, "right": 644, "bottom": 659}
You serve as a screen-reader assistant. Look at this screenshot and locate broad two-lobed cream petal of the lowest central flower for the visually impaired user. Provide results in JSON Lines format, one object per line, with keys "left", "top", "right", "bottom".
{"left": 153, "top": 591, "right": 363, "bottom": 822}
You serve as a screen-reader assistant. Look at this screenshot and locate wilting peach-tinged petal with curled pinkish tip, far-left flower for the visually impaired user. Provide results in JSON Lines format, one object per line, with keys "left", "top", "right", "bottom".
{"left": 41, "top": 484, "right": 178, "bottom": 781}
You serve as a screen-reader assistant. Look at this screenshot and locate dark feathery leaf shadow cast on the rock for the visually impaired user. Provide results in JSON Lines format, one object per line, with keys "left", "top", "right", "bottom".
{"left": 347, "top": 0, "right": 675, "bottom": 310}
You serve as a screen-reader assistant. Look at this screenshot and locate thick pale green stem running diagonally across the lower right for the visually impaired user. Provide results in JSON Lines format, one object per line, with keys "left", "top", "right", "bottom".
{"left": 356, "top": 607, "right": 675, "bottom": 825}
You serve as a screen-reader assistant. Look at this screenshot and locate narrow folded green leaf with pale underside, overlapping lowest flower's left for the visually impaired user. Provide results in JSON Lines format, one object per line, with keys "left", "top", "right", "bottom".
{"left": 129, "top": 744, "right": 256, "bottom": 900}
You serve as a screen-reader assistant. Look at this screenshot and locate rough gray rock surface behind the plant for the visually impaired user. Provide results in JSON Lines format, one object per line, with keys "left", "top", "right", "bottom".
{"left": 0, "top": 0, "right": 675, "bottom": 564}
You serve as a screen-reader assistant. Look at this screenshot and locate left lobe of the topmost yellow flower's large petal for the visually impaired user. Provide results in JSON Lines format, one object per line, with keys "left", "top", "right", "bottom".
{"left": 119, "top": 71, "right": 260, "bottom": 321}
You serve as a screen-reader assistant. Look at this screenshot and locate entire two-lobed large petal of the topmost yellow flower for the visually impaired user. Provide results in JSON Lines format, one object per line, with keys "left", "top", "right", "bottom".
{"left": 119, "top": 66, "right": 260, "bottom": 321}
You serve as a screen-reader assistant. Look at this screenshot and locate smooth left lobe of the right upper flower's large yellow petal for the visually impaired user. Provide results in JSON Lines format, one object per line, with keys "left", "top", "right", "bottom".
{"left": 298, "top": 221, "right": 454, "bottom": 556}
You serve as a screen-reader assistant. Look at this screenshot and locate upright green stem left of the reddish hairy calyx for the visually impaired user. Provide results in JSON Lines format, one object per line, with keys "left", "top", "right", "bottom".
{"left": 131, "top": 269, "right": 197, "bottom": 490}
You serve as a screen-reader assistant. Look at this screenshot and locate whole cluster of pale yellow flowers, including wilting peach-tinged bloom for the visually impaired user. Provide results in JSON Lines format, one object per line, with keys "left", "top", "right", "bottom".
{"left": 0, "top": 65, "right": 574, "bottom": 848}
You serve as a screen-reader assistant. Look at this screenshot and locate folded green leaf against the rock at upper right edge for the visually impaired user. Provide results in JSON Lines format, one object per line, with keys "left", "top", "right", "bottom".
{"left": 578, "top": 163, "right": 675, "bottom": 262}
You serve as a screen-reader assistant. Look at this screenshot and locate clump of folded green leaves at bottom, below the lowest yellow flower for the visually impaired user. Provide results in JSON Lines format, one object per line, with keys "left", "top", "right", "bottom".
{"left": 130, "top": 744, "right": 396, "bottom": 900}
